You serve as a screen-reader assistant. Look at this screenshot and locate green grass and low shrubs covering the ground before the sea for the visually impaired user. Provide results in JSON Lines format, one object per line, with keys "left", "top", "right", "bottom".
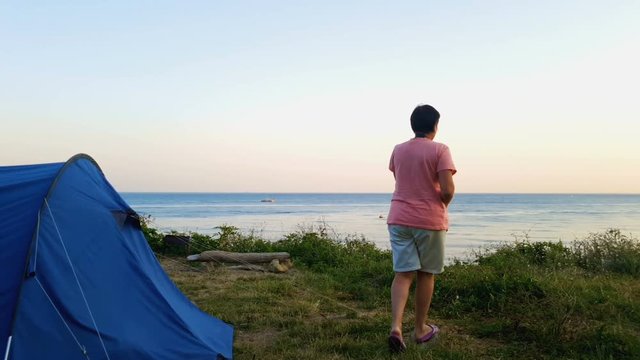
{"left": 151, "top": 227, "right": 640, "bottom": 359}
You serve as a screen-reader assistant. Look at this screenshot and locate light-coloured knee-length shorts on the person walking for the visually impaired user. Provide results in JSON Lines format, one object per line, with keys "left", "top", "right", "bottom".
{"left": 389, "top": 225, "right": 447, "bottom": 274}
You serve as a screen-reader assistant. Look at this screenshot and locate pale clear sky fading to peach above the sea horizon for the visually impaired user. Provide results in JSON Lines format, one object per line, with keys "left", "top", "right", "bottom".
{"left": 0, "top": 0, "right": 640, "bottom": 193}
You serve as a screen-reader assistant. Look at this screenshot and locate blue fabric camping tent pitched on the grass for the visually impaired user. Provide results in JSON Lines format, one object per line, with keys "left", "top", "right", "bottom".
{"left": 0, "top": 154, "right": 233, "bottom": 360}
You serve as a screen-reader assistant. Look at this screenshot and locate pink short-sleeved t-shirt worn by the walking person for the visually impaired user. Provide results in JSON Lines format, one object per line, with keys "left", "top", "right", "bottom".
{"left": 387, "top": 138, "right": 456, "bottom": 230}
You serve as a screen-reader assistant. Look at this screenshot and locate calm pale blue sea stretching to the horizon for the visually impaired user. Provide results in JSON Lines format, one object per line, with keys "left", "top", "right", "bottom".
{"left": 122, "top": 193, "right": 640, "bottom": 257}
